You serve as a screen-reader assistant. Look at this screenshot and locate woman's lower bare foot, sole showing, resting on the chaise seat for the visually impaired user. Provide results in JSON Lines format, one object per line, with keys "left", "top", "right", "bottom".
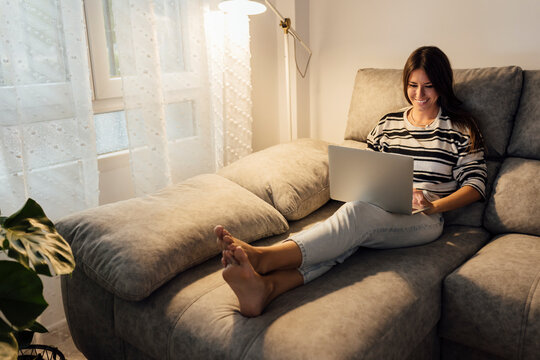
{"left": 223, "top": 246, "right": 272, "bottom": 317}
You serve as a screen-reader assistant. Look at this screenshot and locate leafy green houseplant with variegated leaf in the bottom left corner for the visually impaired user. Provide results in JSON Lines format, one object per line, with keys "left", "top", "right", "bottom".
{"left": 0, "top": 199, "right": 75, "bottom": 360}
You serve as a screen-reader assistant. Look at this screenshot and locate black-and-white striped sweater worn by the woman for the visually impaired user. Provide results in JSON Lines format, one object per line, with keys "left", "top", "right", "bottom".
{"left": 367, "top": 107, "right": 487, "bottom": 201}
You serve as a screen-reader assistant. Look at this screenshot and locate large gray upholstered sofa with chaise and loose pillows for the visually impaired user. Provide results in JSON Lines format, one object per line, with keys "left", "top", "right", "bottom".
{"left": 57, "top": 67, "right": 540, "bottom": 360}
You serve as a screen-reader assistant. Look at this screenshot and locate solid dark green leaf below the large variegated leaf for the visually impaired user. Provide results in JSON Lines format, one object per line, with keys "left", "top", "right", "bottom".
{"left": 0, "top": 260, "right": 48, "bottom": 330}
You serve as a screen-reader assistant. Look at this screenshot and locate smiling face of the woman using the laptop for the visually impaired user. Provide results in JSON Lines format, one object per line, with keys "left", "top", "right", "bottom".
{"left": 407, "top": 69, "right": 439, "bottom": 114}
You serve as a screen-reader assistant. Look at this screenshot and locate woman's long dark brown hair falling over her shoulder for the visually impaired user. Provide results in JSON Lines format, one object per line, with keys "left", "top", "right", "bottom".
{"left": 403, "top": 46, "right": 484, "bottom": 151}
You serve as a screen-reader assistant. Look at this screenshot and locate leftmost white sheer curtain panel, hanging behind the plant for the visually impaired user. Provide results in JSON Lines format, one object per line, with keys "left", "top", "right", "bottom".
{"left": 0, "top": 0, "right": 98, "bottom": 219}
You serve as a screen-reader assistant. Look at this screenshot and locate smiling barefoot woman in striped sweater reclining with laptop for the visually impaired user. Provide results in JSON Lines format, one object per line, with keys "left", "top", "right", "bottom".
{"left": 214, "top": 46, "right": 487, "bottom": 316}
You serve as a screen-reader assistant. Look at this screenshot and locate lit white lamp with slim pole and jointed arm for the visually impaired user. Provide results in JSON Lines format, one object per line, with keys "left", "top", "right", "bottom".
{"left": 218, "top": 0, "right": 312, "bottom": 140}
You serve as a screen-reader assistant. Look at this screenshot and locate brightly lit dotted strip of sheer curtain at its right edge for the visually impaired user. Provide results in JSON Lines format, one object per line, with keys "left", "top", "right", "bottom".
{"left": 205, "top": 11, "right": 253, "bottom": 168}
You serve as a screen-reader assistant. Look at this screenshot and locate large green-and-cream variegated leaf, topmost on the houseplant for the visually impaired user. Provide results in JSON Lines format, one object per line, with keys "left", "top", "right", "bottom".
{"left": 2, "top": 199, "right": 75, "bottom": 276}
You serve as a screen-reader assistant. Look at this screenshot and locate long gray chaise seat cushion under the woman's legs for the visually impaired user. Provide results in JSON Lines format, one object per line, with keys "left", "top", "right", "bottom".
{"left": 115, "top": 217, "right": 489, "bottom": 359}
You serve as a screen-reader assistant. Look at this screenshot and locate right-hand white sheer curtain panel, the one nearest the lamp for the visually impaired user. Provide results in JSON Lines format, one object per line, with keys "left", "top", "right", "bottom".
{"left": 112, "top": 0, "right": 252, "bottom": 195}
